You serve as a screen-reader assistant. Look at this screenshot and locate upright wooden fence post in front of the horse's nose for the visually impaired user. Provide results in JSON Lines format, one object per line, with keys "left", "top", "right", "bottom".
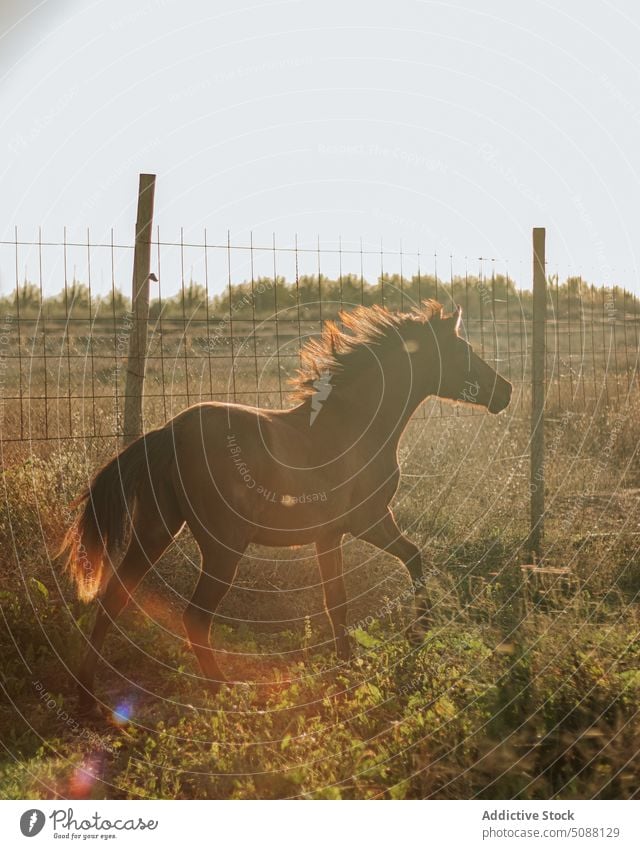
{"left": 529, "top": 227, "right": 547, "bottom": 557}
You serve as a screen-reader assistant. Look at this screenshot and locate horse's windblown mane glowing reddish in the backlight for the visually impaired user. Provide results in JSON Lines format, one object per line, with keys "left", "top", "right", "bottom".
{"left": 289, "top": 300, "right": 442, "bottom": 401}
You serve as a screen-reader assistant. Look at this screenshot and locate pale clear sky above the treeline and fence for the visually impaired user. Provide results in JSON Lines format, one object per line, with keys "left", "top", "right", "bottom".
{"left": 0, "top": 0, "right": 640, "bottom": 293}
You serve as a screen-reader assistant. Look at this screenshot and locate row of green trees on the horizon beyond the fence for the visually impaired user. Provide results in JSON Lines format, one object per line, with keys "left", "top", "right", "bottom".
{"left": 0, "top": 274, "right": 640, "bottom": 321}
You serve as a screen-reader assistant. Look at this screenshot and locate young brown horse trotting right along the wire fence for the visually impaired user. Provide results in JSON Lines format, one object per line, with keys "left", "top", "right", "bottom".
{"left": 62, "top": 301, "right": 511, "bottom": 708}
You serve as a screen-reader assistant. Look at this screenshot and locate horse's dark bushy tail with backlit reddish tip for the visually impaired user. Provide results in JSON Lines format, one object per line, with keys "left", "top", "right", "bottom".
{"left": 58, "top": 426, "right": 174, "bottom": 601}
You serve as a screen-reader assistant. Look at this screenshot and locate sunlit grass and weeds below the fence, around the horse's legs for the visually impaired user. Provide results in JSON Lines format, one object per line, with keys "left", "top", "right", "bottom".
{"left": 0, "top": 390, "right": 640, "bottom": 798}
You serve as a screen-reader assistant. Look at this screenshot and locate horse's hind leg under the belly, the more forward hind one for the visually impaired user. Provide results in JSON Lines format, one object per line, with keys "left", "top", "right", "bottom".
{"left": 183, "top": 539, "right": 246, "bottom": 694}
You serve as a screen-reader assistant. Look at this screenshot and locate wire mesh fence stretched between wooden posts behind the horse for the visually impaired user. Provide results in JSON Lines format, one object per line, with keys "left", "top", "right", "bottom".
{"left": 0, "top": 230, "right": 640, "bottom": 441}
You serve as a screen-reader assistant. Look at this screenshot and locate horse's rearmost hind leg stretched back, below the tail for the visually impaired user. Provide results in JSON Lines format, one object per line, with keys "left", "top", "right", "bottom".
{"left": 78, "top": 496, "right": 182, "bottom": 713}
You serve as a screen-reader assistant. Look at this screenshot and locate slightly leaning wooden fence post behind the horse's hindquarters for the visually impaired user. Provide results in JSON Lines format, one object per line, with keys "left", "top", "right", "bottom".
{"left": 122, "top": 174, "right": 156, "bottom": 446}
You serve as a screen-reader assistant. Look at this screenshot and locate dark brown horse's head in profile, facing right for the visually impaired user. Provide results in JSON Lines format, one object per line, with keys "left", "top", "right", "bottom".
{"left": 412, "top": 306, "right": 512, "bottom": 413}
